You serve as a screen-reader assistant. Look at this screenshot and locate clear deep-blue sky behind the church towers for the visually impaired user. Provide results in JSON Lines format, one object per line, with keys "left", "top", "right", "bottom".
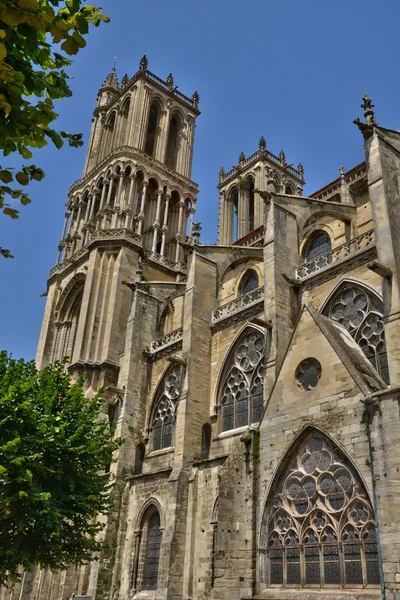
{"left": 0, "top": 0, "right": 400, "bottom": 359}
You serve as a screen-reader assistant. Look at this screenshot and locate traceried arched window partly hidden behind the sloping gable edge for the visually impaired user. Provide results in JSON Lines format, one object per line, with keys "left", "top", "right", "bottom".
{"left": 324, "top": 282, "right": 390, "bottom": 383}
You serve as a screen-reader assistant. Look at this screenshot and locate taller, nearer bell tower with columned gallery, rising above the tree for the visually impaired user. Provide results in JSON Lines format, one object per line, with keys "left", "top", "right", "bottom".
{"left": 37, "top": 56, "right": 200, "bottom": 376}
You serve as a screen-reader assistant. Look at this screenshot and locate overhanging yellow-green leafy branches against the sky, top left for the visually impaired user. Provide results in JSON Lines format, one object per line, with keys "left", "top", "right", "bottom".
{"left": 0, "top": 0, "right": 109, "bottom": 258}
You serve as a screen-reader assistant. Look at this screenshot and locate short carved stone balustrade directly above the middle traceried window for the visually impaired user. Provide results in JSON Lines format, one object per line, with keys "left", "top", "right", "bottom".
{"left": 211, "top": 286, "right": 264, "bottom": 329}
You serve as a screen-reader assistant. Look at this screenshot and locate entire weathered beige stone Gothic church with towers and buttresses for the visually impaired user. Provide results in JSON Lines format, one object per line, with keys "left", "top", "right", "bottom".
{"left": 5, "top": 64, "right": 400, "bottom": 600}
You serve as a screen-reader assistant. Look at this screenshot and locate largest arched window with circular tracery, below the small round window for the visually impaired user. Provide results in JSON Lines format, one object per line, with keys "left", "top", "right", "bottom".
{"left": 262, "top": 432, "right": 379, "bottom": 588}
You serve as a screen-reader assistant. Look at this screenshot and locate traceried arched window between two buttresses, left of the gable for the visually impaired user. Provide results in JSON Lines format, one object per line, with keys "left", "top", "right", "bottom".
{"left": 220, "top": 328, "right": 265, "bottom": 431}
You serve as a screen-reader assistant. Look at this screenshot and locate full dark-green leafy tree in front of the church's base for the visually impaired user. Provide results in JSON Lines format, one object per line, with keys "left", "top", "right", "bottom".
{"left": 0, "top": 351, "right": 122, "bottom": 585}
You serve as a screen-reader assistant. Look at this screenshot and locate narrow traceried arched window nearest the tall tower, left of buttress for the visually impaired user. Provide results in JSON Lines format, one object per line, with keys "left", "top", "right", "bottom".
{"left": 151, "top": 366, "right": 183, "bottom": 450}
